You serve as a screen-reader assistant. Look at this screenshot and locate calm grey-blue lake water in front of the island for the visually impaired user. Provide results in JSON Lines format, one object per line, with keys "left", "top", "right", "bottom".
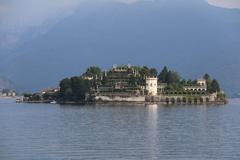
{"left": 0, "top": 100, "right": 240, "bottom": 160}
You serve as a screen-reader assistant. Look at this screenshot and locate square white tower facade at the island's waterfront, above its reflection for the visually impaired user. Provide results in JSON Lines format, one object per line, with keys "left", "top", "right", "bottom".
{"left": 146, "top": 77, "right": 158, "bottom": 96}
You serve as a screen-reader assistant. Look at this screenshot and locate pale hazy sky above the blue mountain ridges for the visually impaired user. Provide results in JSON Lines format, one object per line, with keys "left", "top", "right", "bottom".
{"left": 0, "top": 0, "right": 240, "bottom": 48}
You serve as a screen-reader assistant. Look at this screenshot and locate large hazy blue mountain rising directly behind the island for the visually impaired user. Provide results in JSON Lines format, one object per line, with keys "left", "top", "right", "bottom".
{"left": 0, "top": 0, "right": 240, "bottom": 93}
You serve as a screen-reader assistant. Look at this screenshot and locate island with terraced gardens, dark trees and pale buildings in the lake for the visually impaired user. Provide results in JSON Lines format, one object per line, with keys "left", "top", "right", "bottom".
{"left": 23, "top": 65, "right": 227, "bottom": 104}
